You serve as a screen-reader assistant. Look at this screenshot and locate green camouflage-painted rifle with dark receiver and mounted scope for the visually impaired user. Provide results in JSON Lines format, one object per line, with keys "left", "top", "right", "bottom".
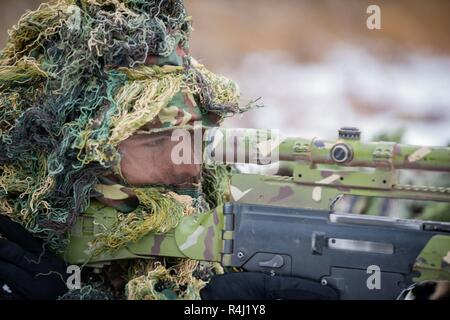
{"left": 66, "top": 128, "right": 450, "bottom": 299}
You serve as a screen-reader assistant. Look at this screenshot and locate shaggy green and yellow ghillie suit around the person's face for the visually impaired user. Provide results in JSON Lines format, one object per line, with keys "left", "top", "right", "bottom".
{"left": 0, "top": 0, "right": 245, "bottom": 296}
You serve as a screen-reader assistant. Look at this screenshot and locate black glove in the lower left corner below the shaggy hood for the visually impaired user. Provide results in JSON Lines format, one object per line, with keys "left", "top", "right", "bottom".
{"left": 0, "top": 215, "right": 67, "bottom": 300}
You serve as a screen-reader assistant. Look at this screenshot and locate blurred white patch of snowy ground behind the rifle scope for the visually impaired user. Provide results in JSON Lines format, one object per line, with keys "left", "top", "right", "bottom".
{"left": 221, "top": 46, "right": 450, "bottom": 145}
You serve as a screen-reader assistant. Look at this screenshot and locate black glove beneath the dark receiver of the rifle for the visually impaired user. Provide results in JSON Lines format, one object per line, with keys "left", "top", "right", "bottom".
{"left": 200, "top": 272, "right": 339, "bottom": 300}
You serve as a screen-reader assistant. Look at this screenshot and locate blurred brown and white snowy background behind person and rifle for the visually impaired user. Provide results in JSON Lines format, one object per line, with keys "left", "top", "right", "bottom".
{"left": 0, "top": 0, "right": 450, "bottom": 145}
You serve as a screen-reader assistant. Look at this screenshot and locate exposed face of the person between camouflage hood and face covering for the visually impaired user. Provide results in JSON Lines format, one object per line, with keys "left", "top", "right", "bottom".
{"left": 119, "top": 132, "right": 201, "bottom": 186}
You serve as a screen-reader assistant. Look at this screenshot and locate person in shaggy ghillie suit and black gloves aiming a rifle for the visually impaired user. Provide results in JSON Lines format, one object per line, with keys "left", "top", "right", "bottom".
{"left": 0, "top": 0, "right": 450, "bottom": 299}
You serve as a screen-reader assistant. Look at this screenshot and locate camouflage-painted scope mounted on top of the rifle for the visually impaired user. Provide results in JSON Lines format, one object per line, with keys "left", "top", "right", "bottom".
{"left": 205, "top": 128, "right": 450, "bottom": 172}
